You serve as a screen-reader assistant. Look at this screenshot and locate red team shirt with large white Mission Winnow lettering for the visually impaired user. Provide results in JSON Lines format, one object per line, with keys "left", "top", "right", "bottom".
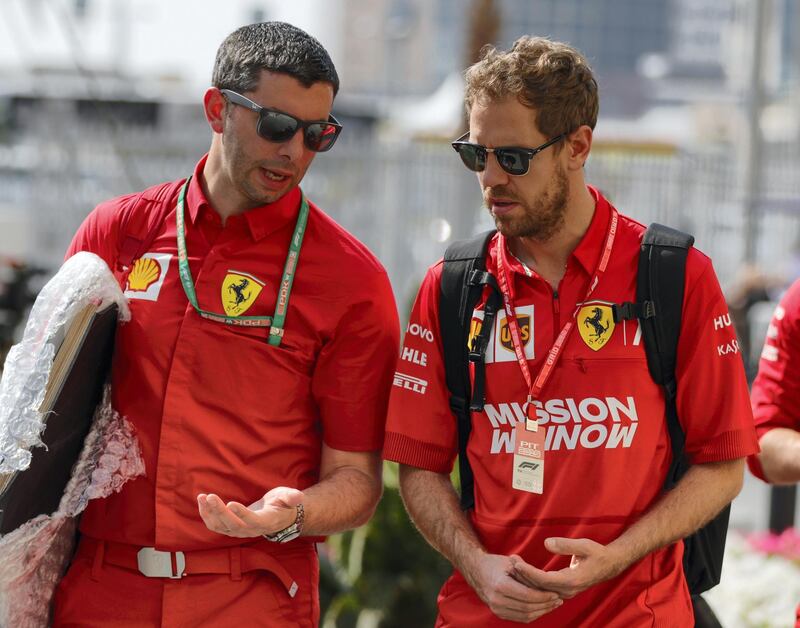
{"left": 384, "top": 188, "right": 757, "bottom": 627}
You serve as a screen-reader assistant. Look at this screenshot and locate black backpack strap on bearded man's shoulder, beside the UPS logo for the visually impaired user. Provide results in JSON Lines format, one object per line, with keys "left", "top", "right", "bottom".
{"left": 439, "top": 231, "right": 501, "bottom": 510}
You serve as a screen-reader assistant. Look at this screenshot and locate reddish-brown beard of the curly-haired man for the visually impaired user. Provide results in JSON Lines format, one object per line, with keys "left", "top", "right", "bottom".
{"left": 486, "top": 165, "right": 569, "bottom": 242}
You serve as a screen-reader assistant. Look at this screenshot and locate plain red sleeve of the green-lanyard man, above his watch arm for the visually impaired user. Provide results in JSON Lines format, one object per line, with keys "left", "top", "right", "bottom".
{"left": 311, "top": 270, "right": 400, "bottom": 451}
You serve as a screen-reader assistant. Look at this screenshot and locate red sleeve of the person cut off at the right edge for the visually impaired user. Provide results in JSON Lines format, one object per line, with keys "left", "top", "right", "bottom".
{"left": 748, "top": 281, "right": 800, "bottom": 479}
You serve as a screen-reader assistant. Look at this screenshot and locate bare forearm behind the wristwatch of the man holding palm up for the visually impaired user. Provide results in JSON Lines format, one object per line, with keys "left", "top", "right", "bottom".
{"left": 303, "top": 459, "right": 383, "bottom": 536}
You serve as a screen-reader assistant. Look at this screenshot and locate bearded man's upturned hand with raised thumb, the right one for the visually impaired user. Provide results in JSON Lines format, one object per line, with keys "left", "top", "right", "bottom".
{"left": 512, "top": 537, "right": 628, "bottom": 599}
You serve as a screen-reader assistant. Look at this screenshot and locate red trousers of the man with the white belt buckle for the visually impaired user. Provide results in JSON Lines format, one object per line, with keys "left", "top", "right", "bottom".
{"left": 53, "top": 543, "right": 319, "bottom": 628}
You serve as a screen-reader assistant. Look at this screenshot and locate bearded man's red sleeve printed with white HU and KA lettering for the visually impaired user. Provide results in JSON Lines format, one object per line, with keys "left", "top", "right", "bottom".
{"left": 676, "top": 249, "right": 758, "bottom": 464}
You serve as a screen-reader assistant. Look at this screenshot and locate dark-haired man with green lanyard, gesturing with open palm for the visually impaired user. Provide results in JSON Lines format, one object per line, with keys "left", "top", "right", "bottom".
{"left": 55, "top": 22, "right": 399, "bottom": 627}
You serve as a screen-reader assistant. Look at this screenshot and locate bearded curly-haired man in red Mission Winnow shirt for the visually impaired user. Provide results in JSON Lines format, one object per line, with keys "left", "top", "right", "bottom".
{"left": 384, "top": 37, "right": 757, "bottom": 628}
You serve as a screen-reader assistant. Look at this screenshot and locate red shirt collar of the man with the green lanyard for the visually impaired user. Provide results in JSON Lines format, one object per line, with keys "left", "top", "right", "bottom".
{"left": 186, "top": 154, "right": 302, "bottom": 242}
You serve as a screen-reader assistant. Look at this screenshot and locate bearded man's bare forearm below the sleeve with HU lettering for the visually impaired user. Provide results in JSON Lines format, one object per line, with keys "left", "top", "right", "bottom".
{"left": 608, "top": 458, "right": 744, "bottom": 567}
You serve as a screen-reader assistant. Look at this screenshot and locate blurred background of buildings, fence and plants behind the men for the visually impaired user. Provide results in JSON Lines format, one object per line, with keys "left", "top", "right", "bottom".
{"left": 0, "top": 0, "right": 800, "bottom": 628}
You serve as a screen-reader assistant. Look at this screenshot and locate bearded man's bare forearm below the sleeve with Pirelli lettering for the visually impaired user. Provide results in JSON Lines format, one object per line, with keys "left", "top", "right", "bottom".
{"left": 400, "top": 464, "right": 484, "bottom": 573}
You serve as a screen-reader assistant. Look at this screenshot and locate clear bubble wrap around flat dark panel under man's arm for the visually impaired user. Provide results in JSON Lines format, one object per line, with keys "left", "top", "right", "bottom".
{"left": 0, "top": 253, "right": 144, "bottom": 628}
